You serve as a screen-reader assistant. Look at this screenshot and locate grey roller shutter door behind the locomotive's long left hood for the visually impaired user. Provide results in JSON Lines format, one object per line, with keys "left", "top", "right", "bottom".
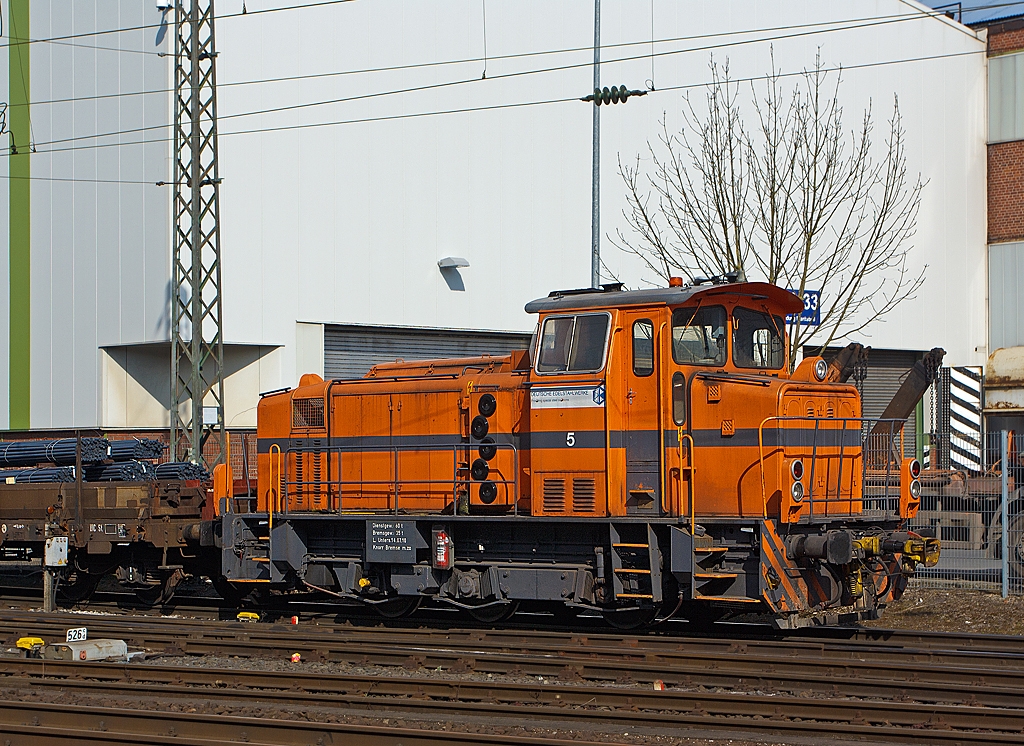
{"left": 324, "top": 324, "right": 530, "bottom": 379}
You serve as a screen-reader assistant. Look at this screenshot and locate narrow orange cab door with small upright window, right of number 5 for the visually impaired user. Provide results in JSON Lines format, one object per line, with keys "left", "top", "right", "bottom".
{"left": 623, "top": 311, "right": 663, "bottom": 516}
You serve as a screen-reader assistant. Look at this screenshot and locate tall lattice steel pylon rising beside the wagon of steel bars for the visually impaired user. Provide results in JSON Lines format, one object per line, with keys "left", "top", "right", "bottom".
{"left": 171, "top": 0, "right": 225, "bottom": 467}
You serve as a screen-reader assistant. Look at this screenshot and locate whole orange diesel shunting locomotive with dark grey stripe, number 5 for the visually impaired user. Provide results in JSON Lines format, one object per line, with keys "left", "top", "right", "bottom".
{"left": 215, "top": 278, "right": 938, "bottom": 626}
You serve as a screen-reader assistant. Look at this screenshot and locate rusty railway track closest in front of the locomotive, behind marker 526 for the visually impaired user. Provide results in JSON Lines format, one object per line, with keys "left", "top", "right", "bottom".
{"left": 6, "top": 612, "right": 1024, "bottom": 707}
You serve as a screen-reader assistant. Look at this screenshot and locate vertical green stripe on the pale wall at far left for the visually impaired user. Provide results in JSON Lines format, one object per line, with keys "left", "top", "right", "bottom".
{"left": 7, "top": 0, "right": 32, "bottom": 430}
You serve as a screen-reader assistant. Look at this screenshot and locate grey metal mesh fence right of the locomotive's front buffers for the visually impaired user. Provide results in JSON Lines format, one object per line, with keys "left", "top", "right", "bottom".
{"left": 911, "top": 431, "right": 1024, "bottom": 596}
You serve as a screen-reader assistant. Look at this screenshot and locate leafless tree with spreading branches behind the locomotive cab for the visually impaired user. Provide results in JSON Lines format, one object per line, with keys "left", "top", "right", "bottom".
{"left": 611, "top": 55, "right": 925, "bottom": 360}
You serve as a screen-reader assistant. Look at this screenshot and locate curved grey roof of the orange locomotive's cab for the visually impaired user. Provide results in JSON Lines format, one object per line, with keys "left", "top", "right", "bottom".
{"left": 526, "top": 282, "right": 804, "bottom": 313}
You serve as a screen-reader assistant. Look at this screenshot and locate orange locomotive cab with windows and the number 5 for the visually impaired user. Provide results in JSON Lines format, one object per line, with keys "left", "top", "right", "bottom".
{"left": 527, "top": 282, "right": 827, "bottom": 517}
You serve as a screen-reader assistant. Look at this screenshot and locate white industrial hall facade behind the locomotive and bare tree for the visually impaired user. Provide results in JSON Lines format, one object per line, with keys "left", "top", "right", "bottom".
{"left": 0, "top": 0, "right": 995, "bottom": 431}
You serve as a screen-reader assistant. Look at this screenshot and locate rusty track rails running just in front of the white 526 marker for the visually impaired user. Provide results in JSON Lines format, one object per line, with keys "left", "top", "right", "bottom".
{"left": 4, "top": 661, "right": 1024, "bottom": 745}
